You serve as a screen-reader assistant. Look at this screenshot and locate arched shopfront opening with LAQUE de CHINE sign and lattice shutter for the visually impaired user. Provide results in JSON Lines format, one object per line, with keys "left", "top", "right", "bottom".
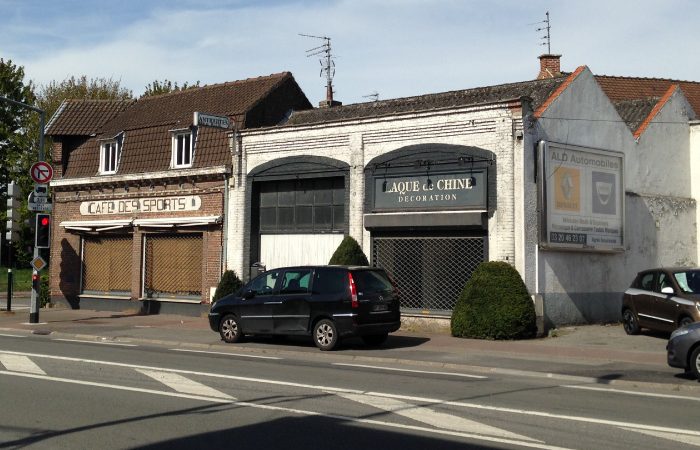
{"left": 364, "top": 144, "right": 496, "bottom": 315}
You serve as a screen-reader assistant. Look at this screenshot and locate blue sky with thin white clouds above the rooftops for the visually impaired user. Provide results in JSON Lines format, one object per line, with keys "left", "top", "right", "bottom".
{"left": 0, "top": 0, "right": 700, "bottom": 105}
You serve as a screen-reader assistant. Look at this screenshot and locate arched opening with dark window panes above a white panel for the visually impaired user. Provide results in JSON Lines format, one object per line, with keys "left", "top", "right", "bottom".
{"left": 248, "top": 156, "right": 350, "bottom": 269}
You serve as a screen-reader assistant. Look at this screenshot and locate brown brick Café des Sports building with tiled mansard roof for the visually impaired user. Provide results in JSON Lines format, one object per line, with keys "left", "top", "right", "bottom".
{"left": 47, "top": 73, "right": 311, "bottom": 311}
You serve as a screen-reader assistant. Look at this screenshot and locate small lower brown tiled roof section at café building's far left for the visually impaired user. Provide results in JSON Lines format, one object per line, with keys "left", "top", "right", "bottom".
{"left": 46, "top": 100, "right": 134, "bottom": 136}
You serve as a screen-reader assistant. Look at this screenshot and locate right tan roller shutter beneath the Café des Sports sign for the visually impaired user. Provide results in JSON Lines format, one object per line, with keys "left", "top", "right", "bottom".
{"left": 144, "top": 233, "right": 204, "bottom": 300}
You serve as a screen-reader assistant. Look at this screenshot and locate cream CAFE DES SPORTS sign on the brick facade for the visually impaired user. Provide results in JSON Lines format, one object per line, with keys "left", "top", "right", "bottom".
{"left": 80, "top": 195, "right": 202, "bottom": 216}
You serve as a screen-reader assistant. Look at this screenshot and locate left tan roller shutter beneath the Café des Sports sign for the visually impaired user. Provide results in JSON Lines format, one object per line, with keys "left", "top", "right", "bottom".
{"left": 82, "top": 236, "right": 132, "bottom": 295}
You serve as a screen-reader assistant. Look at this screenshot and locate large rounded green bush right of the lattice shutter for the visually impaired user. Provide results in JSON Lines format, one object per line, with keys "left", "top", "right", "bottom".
{"left": 451, "top": 261, "right": 537, "bottom": 339}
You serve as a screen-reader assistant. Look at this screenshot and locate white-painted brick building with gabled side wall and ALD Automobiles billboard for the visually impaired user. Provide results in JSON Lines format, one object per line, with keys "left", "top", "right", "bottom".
{"left": 228, "top": 55, "right": 700, "bottom": 326}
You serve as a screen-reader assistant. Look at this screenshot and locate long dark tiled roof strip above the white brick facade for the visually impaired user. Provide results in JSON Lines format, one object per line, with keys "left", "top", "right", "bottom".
{"left": 285, "top": 77, "right": 566, "bottom": 125}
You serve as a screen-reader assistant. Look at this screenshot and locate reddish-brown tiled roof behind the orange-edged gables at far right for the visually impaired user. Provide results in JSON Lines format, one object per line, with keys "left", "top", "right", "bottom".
{"left": 595, "top": 75, "right": 700, "bottom": 120}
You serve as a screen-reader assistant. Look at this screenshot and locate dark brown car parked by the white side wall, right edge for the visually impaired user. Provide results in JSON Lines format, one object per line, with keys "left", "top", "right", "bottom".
{"left": 622, "top": 268, "right": 700, "bottom": 334}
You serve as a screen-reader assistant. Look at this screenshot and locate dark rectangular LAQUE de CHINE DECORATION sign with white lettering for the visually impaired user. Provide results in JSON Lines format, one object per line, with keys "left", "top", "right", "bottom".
{"left": 374, "top": 170, "right": 486, "bottom": 210}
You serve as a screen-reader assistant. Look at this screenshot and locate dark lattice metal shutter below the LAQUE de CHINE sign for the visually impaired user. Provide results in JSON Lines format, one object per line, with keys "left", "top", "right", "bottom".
{"left": 372, "top": 237, "right": 487, "bottom": 312}
